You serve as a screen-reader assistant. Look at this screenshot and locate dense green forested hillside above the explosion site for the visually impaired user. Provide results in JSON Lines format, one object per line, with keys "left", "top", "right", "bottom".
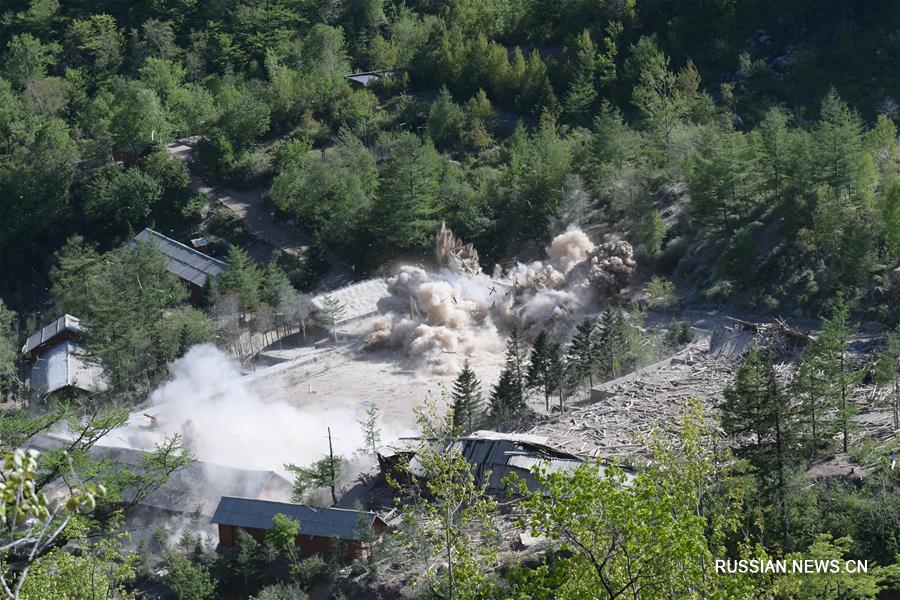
{"left": 0, "top": 0, "right": 900, "bottom": 318}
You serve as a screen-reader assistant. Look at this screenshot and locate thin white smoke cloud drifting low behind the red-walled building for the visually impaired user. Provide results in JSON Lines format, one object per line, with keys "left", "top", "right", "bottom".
{"left": 102, "top": 344, "right": 391, "bottom": 474}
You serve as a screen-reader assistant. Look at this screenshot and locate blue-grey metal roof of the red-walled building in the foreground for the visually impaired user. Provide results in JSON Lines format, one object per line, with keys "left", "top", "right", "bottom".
{"left": 210, "top": 496, "right": 376, "bottom": 540}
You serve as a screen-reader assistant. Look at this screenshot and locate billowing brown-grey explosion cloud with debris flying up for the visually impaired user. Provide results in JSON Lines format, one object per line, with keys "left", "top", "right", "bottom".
{"left": 366, "top": 226, "right": 637, "bottom": 374}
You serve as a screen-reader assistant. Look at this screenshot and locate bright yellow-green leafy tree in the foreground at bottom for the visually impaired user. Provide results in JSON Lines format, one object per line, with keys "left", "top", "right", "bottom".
{"left": 518, "top": 406, "right": 765, "bottom": 599}
